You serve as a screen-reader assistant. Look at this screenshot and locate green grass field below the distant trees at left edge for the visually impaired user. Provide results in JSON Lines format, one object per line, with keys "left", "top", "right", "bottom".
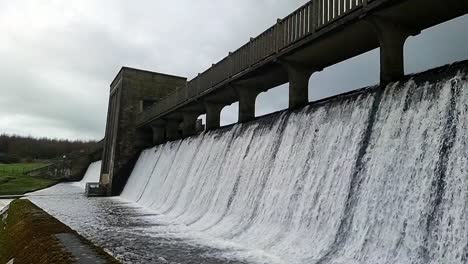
{"left": 0, "top": 163, "right": 57, "bottom": 195}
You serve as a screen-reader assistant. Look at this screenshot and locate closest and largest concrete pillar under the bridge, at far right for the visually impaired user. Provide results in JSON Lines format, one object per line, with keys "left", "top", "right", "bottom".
{"left": 368, "top": 17, "right": 411, "bottom": 84}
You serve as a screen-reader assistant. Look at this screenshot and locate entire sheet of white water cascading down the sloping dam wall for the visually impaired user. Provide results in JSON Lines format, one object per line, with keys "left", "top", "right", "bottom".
{"left": 121, "top": 62, "right": 468, "bottom": 264}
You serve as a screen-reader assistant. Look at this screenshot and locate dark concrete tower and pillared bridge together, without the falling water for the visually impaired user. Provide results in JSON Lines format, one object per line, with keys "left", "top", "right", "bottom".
{"left": 95, "top": 0, "right": 468, "bottom": 195}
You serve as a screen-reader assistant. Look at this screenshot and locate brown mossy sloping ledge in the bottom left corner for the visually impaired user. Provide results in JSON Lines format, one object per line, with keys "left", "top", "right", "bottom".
{"left": 0, "top": 199, "right": 119, "bottom": 264}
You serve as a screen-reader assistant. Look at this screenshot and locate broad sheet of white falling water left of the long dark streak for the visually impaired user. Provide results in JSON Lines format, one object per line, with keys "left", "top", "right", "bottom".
{"left": 123, "top": 88, "right": 374, "bottom": 263}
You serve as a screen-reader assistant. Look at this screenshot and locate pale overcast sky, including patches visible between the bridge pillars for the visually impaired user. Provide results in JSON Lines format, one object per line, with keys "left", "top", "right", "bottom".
{"left": 0, "top": 0, "right": 468, "bottom": 139}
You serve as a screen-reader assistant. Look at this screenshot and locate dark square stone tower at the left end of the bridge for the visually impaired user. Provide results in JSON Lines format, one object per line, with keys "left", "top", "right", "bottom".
{"left": 100, "top": 67, "right": 187, "bottom": 195}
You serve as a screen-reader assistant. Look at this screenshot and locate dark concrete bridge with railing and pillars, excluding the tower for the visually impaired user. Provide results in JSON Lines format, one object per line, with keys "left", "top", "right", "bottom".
{"left": 136, "top": 0, "right": 468, "bottom": 144}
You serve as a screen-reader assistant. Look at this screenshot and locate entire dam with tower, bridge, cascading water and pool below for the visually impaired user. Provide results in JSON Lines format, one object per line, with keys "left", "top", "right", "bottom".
{"left": 19, "top": 0, "right": 468, "bottom": 264}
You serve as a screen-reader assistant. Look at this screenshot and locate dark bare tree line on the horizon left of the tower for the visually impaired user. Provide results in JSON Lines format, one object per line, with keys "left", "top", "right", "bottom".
{"left": 0, "top": 134, "right": 96, "bottom": 163}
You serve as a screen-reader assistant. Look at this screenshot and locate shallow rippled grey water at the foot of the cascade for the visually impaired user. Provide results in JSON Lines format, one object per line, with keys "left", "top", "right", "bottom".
{"left": 28, "top": 184, "right": 247, "bottom": 264}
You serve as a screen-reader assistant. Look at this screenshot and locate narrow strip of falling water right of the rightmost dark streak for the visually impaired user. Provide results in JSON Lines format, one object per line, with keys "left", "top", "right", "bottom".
{"left": 424, "top": 72, "right": 468, "bottom": 263}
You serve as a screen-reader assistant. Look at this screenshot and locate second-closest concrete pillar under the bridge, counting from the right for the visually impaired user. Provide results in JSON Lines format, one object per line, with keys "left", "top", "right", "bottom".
{"left": 282, "top": 62, "right": 316, "bottom": 109}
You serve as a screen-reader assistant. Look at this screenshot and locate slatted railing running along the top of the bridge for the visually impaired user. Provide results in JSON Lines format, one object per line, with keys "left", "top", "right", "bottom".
{"left": 138, "top": 0, "right": 376, "bottom": 124}
